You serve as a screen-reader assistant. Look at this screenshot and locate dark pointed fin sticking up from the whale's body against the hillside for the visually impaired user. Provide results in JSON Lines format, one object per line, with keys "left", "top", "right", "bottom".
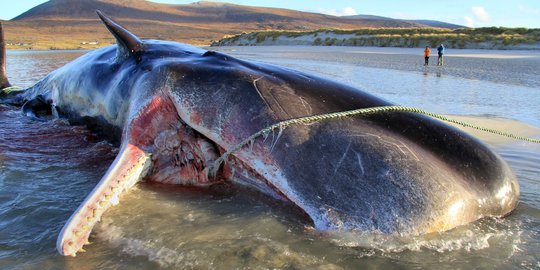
{"left": 96, "top": 10, "right": 144, "bottom": 62}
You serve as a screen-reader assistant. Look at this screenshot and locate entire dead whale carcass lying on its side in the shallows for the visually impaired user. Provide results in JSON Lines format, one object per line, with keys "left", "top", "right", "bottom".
{"left": 0, "top": 11, "right": 519, "bottom": 255}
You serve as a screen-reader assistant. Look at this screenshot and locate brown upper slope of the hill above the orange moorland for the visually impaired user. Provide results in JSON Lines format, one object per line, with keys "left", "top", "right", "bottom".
{"left": 13, "top": 0, "right": 419, "bottom": 29}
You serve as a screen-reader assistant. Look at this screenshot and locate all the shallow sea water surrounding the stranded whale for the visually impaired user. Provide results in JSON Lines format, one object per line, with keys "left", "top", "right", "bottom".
{"left": 0, "top": 47, "right": 540, "bottom": 269}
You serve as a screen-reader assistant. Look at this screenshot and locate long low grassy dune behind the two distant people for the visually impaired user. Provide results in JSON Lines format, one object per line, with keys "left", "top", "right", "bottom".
{"left": 212, "top": 27, "right": 540, "bottom": 49}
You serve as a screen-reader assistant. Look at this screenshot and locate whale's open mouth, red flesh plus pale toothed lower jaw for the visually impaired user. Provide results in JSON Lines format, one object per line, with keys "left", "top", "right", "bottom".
{"left": 56, "top": 94, "right": 286, "bottom": 256}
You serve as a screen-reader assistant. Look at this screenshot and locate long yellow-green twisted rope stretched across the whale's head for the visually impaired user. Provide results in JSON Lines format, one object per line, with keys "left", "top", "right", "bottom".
{"left": 209, "top": 106, "right": 540, "bottom": 174}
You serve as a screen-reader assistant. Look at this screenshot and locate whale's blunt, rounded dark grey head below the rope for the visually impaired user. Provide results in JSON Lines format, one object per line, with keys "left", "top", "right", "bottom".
{"left": 247, "top": 120, "right": 519, "bottom": 235}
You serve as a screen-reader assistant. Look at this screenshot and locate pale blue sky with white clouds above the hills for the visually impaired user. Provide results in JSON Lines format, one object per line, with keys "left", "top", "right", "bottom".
{"left": 0, "top": 0, "right": 540, "bottom": 28}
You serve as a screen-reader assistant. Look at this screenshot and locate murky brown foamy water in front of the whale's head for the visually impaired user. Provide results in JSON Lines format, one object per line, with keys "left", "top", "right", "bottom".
{"left": 87, "top": 170, "right": 538, "bottom": 268}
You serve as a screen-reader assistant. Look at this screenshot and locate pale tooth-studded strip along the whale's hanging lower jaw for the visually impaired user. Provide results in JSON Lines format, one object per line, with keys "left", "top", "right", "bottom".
{"left": 66, "top": 156, "right": 148, "bottom": 256}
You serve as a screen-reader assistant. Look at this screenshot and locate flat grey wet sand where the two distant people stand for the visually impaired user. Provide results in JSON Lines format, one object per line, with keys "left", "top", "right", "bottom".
{"left": 211, "top": 46, "right": 540, "bottom": 88}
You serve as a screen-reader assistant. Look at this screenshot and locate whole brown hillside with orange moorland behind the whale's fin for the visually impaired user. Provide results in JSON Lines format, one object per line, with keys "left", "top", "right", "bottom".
{"left": 5, "top": 0, "right": 434, "bottom": 49}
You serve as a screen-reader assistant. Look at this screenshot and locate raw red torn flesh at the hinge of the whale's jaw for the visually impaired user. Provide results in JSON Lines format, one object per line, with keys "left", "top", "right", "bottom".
{"left": 128, "top": 94, "right": 234, "bottom": 187}
